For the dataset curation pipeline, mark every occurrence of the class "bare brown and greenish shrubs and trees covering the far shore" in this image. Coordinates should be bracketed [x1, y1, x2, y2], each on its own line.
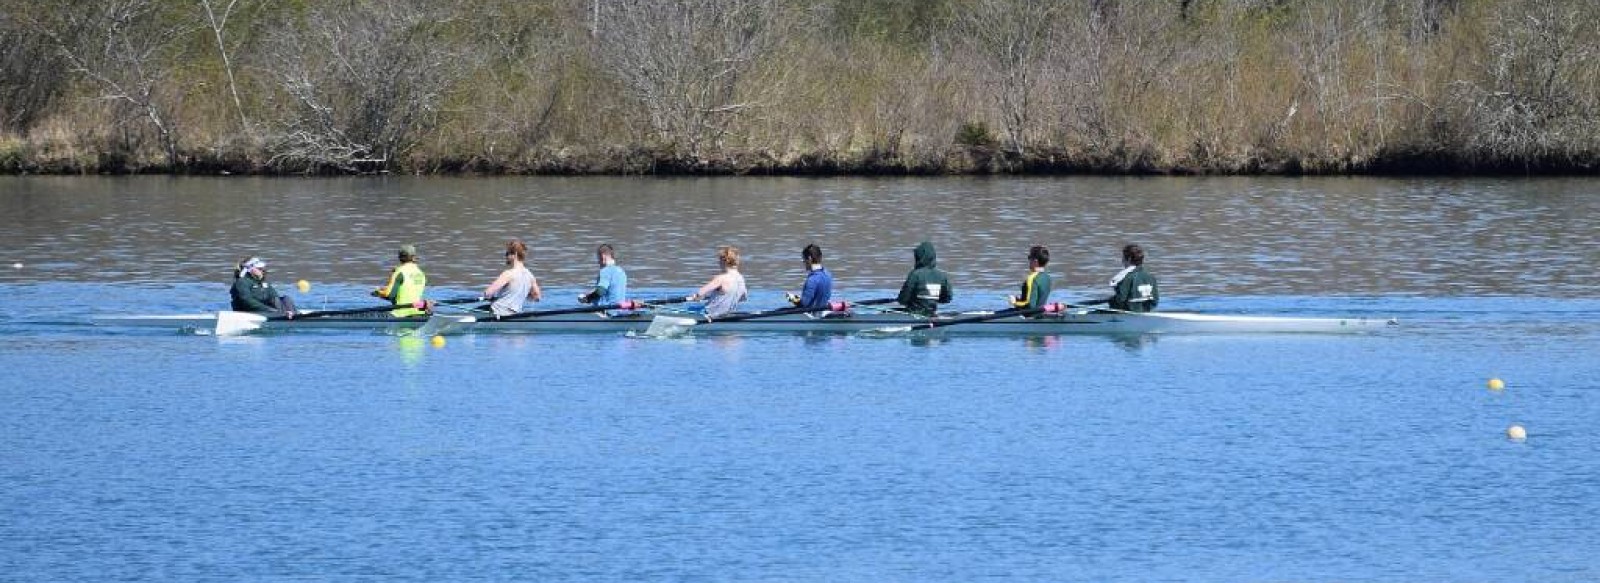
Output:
[0, 0, 1600, 175]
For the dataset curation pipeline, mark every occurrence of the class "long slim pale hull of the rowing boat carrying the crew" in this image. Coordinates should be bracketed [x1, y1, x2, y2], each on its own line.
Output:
[93, 309, 1397, 336]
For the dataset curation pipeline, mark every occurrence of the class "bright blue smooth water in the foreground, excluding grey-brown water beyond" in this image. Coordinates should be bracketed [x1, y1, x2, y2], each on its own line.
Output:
[0, 283, 1600, 581]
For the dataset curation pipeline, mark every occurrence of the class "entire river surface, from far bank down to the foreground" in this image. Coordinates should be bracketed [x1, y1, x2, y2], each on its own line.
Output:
[0, 178, 1600, 581]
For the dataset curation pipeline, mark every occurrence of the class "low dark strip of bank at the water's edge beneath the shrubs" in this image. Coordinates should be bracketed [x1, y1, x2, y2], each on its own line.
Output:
[9, 146, 1600, 176]
